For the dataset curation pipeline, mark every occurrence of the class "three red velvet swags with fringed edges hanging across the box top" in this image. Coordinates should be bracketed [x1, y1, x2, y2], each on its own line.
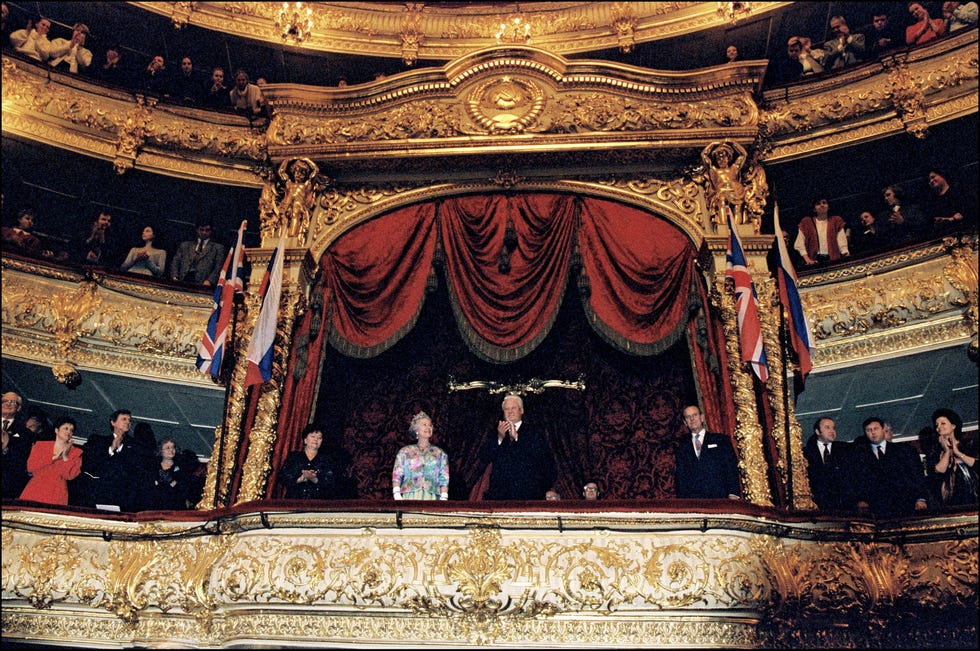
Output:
[322, 194, 697, 363]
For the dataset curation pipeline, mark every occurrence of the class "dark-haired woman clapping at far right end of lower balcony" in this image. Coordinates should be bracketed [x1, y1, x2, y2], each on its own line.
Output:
[926, 408, 977, 506]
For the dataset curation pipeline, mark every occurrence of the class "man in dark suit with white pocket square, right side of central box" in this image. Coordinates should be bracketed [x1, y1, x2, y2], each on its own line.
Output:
[674, 405, 741, 500]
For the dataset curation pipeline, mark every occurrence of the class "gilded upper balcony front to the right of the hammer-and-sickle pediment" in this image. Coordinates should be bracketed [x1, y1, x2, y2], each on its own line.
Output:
[759, 30, 978, 163]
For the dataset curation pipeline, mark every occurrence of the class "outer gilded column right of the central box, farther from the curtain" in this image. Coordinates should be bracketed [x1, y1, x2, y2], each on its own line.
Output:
[755, 277, 816, 509]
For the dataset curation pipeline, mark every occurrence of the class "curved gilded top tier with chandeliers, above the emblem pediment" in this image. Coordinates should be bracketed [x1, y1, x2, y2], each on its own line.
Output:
[130, 2, 790, 60]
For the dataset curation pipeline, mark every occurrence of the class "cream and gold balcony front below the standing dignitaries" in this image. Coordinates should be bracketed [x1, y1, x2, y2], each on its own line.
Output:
[0, 508, 978, 648]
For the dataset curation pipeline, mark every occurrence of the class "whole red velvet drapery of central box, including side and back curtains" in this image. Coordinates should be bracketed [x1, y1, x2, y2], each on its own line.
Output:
[267, 193, 731, 499]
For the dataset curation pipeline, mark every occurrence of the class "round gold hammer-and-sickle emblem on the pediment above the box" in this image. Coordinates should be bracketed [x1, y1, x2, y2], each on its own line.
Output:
[466, 76, 545, 134]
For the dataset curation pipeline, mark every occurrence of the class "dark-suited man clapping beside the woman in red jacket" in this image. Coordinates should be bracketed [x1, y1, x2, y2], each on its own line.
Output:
[70, 409, 145, 511]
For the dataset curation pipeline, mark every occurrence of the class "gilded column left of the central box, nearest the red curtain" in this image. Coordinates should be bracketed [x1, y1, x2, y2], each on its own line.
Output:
[235, 291, 306, 504]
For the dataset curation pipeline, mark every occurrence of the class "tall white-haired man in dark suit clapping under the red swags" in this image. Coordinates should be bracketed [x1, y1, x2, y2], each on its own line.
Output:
[480, 395, 557, 500]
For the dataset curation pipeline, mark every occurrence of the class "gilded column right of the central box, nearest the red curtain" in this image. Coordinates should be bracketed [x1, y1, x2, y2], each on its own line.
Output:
[711, 271, 772, 506]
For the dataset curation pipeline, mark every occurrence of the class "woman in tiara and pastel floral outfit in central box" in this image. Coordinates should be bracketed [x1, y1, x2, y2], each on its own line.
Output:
[391, 411, 449, 500]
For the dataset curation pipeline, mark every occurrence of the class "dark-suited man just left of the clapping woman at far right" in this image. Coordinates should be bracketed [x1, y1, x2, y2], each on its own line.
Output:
[847, 416, 929, 518]
